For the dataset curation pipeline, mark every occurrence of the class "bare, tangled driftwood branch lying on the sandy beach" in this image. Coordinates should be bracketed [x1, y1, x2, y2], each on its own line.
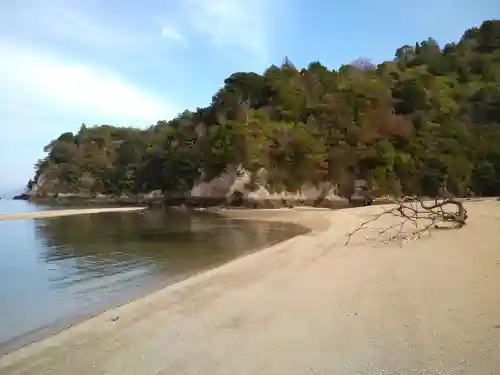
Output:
[345, 197, 467, 245]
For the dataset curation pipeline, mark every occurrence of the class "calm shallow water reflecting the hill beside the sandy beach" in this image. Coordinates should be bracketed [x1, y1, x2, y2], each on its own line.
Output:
[0, 200, 303, 353]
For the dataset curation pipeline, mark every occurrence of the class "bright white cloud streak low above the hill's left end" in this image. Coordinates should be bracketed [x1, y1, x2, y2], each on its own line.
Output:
[0, 42, 175, 124]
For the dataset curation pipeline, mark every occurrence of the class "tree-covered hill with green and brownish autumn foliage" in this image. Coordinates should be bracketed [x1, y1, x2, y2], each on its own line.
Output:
[34, 21, 500, 200]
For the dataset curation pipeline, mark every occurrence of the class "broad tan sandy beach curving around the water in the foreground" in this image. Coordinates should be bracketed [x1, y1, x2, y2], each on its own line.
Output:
[0, 201, 500, 375]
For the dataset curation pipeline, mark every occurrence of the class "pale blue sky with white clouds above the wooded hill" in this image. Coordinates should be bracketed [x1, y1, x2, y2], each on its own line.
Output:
[0, 0, 500, 189]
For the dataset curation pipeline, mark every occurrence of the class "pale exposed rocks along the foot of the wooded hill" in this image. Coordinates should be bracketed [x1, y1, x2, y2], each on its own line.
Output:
[24, 165, 347, 208]
